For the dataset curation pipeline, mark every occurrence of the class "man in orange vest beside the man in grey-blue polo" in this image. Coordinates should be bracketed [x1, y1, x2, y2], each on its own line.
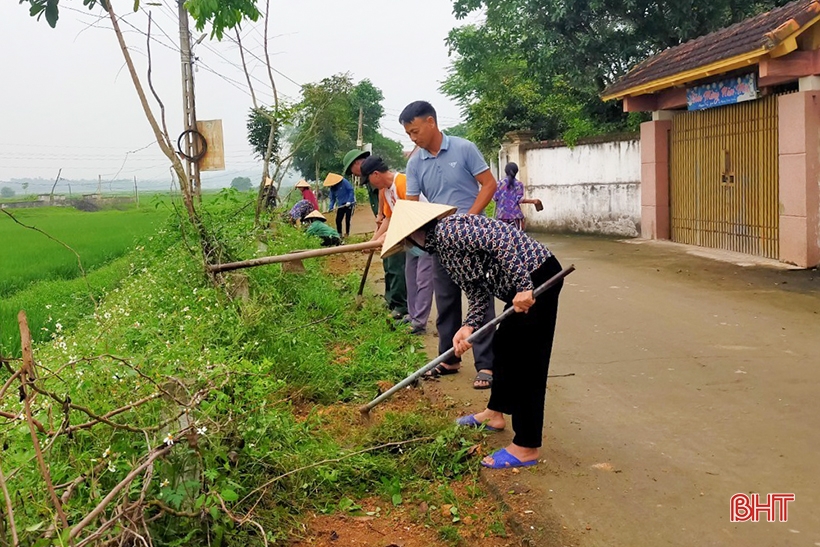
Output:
[361, 156, 433, 335]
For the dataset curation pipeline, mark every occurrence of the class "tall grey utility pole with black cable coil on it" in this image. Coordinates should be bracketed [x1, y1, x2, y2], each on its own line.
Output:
[178, 0, 202, 202]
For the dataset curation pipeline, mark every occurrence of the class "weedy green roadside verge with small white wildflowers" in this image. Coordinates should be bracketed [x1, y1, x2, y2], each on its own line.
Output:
[0, 191, 486, 546]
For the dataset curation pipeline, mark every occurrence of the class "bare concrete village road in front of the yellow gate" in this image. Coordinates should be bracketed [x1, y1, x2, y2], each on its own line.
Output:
[428, 235, 820, 547]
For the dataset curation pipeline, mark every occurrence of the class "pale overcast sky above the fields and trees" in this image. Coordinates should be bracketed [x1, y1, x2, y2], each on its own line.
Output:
[0, 0, 474, 189]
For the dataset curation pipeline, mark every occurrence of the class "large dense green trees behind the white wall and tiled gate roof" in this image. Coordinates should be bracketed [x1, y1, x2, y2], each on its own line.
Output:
[442, 0, 788, 152]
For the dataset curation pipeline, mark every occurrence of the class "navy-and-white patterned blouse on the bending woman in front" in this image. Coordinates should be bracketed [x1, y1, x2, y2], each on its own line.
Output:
[424, 215, 552, 328]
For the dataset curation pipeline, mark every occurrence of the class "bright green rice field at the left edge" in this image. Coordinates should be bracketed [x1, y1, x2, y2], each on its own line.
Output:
[0, 205, 168, 298]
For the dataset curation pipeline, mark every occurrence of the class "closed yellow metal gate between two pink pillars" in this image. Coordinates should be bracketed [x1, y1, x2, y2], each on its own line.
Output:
[669, 96, 779, 259]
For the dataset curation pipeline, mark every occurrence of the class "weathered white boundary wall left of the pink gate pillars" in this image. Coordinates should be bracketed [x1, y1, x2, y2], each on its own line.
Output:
[499, 136, 641, 237]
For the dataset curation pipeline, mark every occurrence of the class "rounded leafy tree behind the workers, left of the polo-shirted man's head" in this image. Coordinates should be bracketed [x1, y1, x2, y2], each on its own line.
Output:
[289, 74, 406, 180]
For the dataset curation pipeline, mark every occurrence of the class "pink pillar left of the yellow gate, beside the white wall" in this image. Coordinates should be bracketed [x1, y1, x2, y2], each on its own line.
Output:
[641, 120, 672, 239]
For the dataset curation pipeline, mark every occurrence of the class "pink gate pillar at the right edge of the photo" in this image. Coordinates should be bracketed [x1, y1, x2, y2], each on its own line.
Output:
[778, 91, 820, 268]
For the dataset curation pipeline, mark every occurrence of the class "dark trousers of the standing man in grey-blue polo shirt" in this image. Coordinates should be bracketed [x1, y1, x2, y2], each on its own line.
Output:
[433, 255, 495, 370]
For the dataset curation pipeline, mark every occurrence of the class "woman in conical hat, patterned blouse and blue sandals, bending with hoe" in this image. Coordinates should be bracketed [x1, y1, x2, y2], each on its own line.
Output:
[381, 200, 562, 469]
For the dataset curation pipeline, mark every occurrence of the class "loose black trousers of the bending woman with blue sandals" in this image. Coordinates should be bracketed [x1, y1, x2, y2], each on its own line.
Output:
[487, 257, 563, 448]
